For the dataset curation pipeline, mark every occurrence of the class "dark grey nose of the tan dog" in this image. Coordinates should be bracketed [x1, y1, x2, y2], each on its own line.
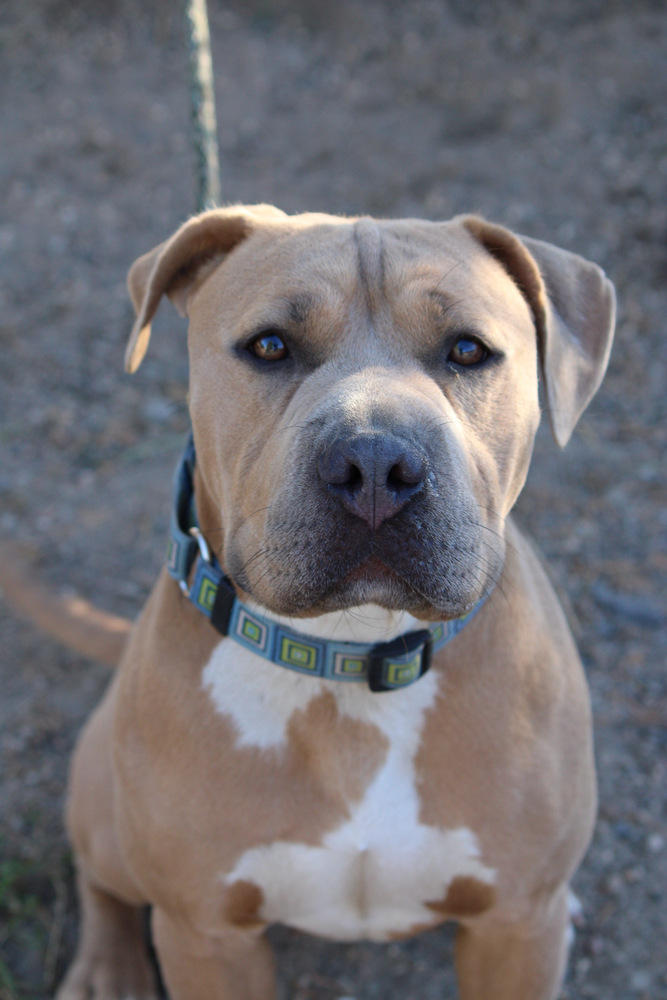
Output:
[317, 433, 428, 529]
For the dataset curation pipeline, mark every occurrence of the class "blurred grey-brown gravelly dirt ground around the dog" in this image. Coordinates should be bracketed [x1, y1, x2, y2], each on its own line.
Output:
[0, 0, 667, 1000]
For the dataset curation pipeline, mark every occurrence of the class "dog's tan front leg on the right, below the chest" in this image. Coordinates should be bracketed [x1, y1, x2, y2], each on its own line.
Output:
[456, 887, 570, 1000]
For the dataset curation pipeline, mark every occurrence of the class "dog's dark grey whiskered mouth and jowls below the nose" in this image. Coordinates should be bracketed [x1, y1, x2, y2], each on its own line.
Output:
[227, 480, 504, 620]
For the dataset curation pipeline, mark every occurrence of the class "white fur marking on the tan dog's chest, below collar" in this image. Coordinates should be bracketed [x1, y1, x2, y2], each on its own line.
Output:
[204, 643, 494, 941]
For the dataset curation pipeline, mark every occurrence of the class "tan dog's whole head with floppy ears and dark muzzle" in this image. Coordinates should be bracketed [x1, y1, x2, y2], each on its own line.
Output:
[126, 206, 614, 619]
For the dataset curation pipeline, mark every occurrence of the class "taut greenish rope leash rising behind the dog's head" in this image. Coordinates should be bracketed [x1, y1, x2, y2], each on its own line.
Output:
[185, 0, 220, 212]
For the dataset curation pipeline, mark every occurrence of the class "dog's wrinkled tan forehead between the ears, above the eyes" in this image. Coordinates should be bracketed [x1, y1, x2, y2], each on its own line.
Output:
[192, 215, 528, 344]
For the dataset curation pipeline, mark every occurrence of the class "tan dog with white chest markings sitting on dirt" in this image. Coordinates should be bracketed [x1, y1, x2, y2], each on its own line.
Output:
[58, 206, 614, 1000]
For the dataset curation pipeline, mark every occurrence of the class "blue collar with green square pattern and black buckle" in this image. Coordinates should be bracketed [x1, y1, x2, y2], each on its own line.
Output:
[167, 434, 486, 691]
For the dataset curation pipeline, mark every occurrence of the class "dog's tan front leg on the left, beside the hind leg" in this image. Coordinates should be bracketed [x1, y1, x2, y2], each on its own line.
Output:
[153, 909, 276, 1000]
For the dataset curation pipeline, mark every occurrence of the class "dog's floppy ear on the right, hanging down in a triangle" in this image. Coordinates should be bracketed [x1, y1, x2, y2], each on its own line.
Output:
[462, 216, 616, 448]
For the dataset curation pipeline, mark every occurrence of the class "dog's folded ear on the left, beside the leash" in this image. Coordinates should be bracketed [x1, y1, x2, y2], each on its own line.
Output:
[125, 205, 285, 372]
